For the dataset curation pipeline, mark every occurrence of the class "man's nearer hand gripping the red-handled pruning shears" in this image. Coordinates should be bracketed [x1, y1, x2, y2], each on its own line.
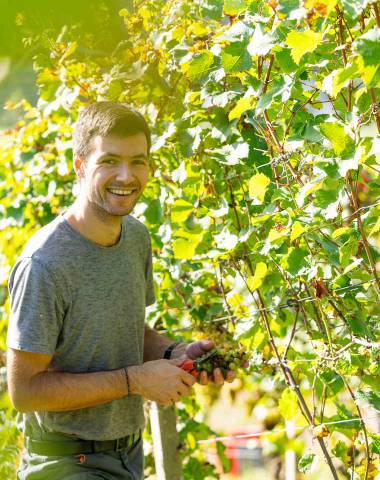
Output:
[128, 359, 195, 405]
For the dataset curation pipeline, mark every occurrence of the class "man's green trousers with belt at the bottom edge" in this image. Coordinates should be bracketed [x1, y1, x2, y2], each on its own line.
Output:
[17, 438, 144, 480]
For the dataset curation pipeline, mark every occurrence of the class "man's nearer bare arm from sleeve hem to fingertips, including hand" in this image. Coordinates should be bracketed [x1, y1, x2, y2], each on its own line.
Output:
[7, 349, 195, 412]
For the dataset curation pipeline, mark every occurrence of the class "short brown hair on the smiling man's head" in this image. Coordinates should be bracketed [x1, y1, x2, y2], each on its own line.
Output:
[73, 101, 151, 160]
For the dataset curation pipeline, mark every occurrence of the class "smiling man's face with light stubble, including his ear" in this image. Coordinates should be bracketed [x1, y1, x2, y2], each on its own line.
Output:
[75, 133, 150, 216]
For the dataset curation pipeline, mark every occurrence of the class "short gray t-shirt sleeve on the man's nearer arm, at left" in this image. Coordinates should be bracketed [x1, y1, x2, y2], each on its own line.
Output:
[7, 258, 64, 354]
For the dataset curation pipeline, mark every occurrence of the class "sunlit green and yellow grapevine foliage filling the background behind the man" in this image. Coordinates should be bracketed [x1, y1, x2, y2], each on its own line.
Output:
[0, 0, 380, 479]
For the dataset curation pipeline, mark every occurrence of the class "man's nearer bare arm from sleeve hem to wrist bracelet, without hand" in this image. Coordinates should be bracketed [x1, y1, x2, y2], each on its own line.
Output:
[7, 348, 128, 412]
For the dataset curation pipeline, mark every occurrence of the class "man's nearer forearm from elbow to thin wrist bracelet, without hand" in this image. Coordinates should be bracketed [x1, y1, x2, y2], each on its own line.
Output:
[14, 369, 128, 412]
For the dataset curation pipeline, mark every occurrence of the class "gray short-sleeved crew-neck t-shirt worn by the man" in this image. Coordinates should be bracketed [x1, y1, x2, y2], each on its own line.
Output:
[7, 215, 155, 440]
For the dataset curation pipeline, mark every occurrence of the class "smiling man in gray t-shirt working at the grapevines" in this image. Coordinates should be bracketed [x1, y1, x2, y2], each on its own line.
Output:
[7, 102, 233, 480]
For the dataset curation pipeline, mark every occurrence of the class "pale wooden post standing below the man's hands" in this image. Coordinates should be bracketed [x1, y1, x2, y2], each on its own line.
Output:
[150, 402, 182, 480]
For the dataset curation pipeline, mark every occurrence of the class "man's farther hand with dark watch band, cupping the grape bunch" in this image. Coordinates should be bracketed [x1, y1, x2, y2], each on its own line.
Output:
[173, 340, 236, 385]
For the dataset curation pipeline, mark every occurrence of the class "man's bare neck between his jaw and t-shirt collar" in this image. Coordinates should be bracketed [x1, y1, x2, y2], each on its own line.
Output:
[63, 197, 122, 247]
